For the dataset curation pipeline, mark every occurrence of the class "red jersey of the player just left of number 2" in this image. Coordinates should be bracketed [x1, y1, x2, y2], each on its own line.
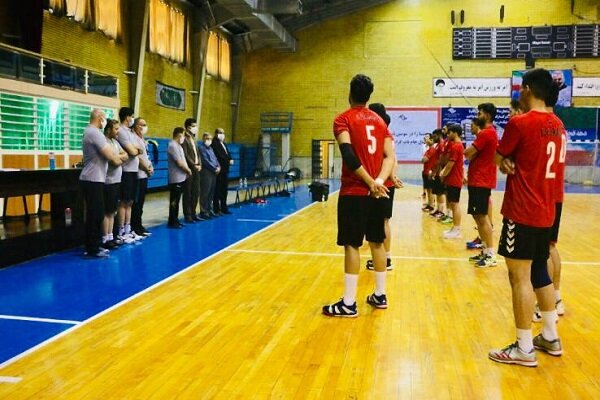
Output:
[468, 126, 498, 189]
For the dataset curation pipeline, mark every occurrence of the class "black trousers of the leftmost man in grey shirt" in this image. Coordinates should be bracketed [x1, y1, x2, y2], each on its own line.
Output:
[80, 181, 104, 254]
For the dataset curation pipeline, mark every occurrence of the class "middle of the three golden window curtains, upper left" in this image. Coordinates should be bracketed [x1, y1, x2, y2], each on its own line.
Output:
[150, 0, 186, 63]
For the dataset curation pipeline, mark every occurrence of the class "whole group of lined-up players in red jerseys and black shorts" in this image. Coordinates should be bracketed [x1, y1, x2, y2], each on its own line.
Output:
[322, 68, 567, 367]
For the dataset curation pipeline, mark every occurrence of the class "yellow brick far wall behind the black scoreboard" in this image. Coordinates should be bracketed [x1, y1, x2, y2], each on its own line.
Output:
[236, 0, 600, 156]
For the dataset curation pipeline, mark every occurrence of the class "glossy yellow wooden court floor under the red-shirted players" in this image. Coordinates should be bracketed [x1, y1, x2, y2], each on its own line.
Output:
[0, 187, 600, 399]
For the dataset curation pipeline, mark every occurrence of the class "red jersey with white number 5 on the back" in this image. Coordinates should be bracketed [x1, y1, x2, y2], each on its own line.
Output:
[333, 106, 392, 196]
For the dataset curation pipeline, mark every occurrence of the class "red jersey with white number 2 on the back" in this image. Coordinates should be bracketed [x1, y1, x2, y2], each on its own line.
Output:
[497, 110, 565, 228]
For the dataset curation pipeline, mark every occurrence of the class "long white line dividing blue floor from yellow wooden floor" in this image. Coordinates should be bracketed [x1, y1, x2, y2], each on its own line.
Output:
[0, 192, 328, 370]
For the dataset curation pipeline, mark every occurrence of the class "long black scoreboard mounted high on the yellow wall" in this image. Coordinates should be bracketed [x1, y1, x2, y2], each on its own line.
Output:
[452, 24, 600, 60]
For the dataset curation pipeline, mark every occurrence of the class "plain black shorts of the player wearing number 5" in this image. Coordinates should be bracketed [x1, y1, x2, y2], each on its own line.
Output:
[337, 196, 387, 247]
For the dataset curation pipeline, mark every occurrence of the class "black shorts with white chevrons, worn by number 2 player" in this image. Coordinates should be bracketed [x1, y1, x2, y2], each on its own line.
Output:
[498, 218, 551, 265]
